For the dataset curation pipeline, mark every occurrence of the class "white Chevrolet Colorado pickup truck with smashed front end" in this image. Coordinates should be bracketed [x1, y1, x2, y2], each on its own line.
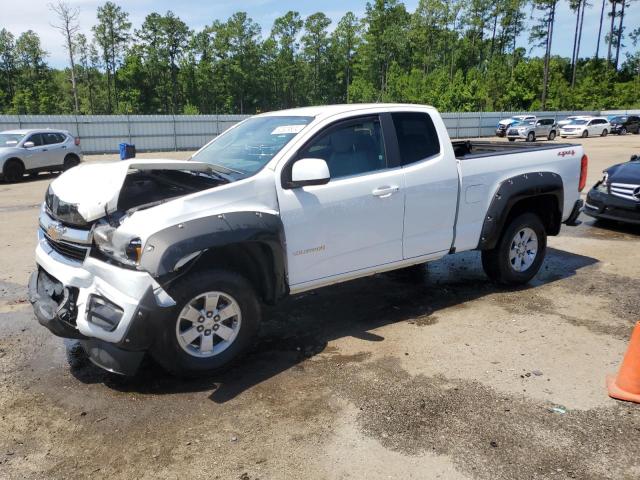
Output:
[29, 104, 587, 375]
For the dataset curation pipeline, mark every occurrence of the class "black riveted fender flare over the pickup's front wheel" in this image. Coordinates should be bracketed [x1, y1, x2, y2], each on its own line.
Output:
[140, 211, 289, 303]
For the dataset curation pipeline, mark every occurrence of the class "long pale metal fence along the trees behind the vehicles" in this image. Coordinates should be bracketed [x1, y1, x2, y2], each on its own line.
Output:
[0, 111, 620, 153]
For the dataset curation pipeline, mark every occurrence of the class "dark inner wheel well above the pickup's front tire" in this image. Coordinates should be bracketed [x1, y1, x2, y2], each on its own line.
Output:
[191, 242, 283, 304]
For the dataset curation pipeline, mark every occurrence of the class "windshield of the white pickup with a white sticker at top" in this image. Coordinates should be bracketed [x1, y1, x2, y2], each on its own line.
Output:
[192, 116, 313, 178]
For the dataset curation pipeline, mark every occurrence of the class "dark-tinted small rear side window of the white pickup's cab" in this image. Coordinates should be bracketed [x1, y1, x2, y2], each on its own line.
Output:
[391, 112, 440, 165]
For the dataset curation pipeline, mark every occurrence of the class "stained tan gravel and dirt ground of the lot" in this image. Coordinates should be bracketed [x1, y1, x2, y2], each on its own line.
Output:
[0, 135, 640, 480]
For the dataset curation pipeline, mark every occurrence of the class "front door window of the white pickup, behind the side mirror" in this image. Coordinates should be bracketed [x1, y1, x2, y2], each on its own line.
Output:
[298, 118, 387, 180]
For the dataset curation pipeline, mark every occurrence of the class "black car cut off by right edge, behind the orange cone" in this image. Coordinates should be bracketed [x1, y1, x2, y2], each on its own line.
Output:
[584, 155, 640, 224]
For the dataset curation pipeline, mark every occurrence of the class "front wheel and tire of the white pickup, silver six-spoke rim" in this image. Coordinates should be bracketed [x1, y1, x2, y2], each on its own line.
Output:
[150, 270, 260, 377]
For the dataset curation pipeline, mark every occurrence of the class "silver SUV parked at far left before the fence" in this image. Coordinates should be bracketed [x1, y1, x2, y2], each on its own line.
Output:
[0, 129, 83, 182]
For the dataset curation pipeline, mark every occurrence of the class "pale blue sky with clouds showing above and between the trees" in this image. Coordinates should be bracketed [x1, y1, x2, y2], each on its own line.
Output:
[0, 0, 640, 68]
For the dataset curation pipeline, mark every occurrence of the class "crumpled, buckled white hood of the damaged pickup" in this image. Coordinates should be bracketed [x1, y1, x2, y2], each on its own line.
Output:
[50, 160, 216, 222]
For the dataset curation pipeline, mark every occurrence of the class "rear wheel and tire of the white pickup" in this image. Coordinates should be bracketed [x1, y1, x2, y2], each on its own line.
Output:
[482, 213, 547, 285]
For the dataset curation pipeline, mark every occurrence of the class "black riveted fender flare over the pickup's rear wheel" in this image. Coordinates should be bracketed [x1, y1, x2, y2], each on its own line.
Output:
[478, 172, 564, 250]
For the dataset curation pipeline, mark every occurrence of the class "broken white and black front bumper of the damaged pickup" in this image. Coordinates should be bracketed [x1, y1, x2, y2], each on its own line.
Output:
[29, 234, 175, 373]
